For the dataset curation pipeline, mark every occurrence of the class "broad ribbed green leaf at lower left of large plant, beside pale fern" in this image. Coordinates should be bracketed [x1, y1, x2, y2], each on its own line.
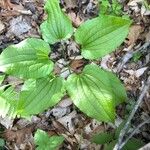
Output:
[17, 77, 65, 117]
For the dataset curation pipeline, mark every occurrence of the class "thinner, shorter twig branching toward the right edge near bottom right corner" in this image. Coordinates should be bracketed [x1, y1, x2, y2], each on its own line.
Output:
[120, 119, 150, 149]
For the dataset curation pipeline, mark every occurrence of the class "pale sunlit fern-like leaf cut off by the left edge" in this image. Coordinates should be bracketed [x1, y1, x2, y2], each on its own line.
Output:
[0, 87, 18, 118]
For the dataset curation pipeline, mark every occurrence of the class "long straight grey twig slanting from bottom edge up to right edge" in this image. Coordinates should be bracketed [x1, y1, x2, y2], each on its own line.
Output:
[113, 76, 150, 150]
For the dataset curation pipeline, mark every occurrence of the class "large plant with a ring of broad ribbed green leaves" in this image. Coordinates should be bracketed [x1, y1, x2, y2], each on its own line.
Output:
[0, 0, 131, 122]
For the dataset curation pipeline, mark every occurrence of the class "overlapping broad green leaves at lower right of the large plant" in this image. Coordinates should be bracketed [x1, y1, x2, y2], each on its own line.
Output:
[66, 65, 126, 122]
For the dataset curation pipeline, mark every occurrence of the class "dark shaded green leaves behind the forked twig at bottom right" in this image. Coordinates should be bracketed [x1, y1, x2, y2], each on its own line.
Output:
[91, 122, 144, 150]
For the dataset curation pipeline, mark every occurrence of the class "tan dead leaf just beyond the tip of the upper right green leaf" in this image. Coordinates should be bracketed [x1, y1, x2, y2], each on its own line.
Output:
[127, 25, 143, 45]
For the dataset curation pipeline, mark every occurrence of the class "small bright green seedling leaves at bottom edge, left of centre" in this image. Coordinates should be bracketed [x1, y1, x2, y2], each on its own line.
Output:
[34, 129, 64, 150]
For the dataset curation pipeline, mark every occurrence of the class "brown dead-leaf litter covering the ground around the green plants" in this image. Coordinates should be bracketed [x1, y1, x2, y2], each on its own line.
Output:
[0, 0, 150, 150]
